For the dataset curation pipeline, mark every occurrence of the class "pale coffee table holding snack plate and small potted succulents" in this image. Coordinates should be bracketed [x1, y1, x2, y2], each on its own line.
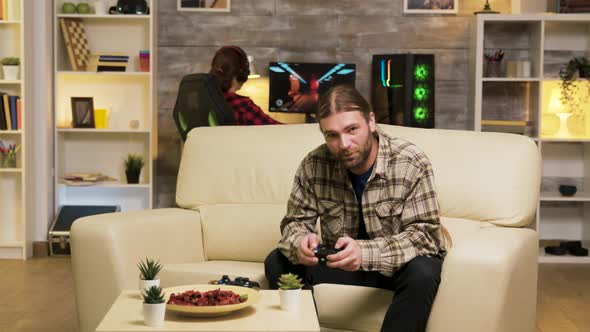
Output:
[96, 290, 320, 332]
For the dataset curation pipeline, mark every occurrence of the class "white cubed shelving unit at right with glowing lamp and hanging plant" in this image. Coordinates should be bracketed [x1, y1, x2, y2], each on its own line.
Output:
[472, 14, 590, 264]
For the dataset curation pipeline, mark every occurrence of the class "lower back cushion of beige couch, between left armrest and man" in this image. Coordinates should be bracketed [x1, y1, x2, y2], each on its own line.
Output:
[198, 204, 287, 262]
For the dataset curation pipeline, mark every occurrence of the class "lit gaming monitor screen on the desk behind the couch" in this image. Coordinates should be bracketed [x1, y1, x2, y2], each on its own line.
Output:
[268, 62, 356, 114]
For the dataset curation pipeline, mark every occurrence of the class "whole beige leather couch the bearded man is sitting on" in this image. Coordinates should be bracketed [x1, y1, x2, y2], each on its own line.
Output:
[72, 124, 540, 332]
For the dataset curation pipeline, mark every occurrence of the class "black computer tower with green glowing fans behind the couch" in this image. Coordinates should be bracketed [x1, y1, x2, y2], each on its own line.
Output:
[371, 54, 435, 128]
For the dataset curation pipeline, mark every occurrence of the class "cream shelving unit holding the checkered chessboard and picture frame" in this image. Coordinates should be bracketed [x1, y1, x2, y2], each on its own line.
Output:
[54, 0, 157, 213]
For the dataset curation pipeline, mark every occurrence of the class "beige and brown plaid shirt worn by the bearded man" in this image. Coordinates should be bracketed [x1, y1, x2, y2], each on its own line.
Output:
[279, 132, 446, 276]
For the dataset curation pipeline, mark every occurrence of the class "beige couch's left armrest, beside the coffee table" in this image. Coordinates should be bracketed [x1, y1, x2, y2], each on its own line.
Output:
[71, 209, 204, 332]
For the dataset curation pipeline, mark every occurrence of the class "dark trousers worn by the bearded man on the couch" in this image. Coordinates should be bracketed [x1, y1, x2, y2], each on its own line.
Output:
[264, 249, 442, 332]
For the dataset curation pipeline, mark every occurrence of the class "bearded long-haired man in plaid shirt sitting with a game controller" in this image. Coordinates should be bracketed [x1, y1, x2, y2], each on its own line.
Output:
[265, 86, 450, 332]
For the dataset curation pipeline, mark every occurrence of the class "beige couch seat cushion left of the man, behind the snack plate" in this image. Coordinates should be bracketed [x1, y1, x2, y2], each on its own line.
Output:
[159, 261, 268, 289]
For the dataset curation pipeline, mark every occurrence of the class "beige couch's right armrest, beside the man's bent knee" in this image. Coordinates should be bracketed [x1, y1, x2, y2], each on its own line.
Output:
[428, 227, 538, 332]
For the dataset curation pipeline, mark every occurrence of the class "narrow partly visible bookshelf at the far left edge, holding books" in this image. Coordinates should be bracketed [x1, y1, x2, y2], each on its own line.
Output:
[0, 0, 34, 259]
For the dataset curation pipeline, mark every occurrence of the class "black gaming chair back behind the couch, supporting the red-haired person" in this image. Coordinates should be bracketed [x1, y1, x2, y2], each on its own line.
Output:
[172, 74, 236, 142]
